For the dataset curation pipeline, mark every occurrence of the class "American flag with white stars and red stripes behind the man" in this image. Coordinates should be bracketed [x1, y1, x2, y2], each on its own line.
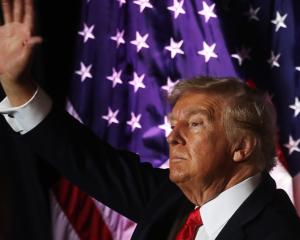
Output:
[52, 0, 300, 239]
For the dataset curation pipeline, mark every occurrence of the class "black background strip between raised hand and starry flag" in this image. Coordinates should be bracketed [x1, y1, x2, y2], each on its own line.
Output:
[33, 0, 82, 105]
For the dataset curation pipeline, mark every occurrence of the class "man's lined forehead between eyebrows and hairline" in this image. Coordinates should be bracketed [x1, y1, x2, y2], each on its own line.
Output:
[170, 91, 224, 118]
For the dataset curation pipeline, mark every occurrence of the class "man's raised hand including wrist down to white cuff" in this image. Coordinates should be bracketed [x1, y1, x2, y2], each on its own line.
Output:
[0, 0, 42, 105]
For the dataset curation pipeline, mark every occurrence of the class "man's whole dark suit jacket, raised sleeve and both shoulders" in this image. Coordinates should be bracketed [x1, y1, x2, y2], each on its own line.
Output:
[14, 110, 300, 240]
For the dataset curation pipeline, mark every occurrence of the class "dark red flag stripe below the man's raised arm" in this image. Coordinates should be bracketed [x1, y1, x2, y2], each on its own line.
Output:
[52, 177, 112, 240]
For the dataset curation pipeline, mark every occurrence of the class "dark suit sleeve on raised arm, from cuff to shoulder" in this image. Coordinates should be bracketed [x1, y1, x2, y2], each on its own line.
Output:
[18, 107, 170, 222]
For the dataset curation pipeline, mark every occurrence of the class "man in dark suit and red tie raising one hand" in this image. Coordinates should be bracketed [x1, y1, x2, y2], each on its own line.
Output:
[0, 0, 300, 240]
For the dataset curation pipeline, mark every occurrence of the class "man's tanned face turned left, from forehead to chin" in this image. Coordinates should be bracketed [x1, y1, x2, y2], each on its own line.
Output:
[168, 91, 233, 189]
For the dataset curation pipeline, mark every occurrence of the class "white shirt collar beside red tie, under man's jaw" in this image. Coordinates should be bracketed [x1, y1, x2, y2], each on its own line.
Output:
[200, 173, 261, 237]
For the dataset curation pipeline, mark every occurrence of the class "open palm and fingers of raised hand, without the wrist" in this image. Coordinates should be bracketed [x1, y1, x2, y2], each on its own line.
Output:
[0, 0, 41, 81]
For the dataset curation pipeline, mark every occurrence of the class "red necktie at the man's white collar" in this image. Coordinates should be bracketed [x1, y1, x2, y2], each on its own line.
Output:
[176, 207, 203, 240]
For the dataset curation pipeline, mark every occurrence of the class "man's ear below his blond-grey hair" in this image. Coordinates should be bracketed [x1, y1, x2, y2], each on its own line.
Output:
[232, 134, 257, 162]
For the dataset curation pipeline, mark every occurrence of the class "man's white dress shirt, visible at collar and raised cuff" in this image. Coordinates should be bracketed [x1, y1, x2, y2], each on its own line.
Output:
[0, 88, 260, 240]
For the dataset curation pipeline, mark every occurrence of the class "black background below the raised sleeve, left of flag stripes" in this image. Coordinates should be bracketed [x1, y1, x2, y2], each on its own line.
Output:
[0, 116, 55, 240]
